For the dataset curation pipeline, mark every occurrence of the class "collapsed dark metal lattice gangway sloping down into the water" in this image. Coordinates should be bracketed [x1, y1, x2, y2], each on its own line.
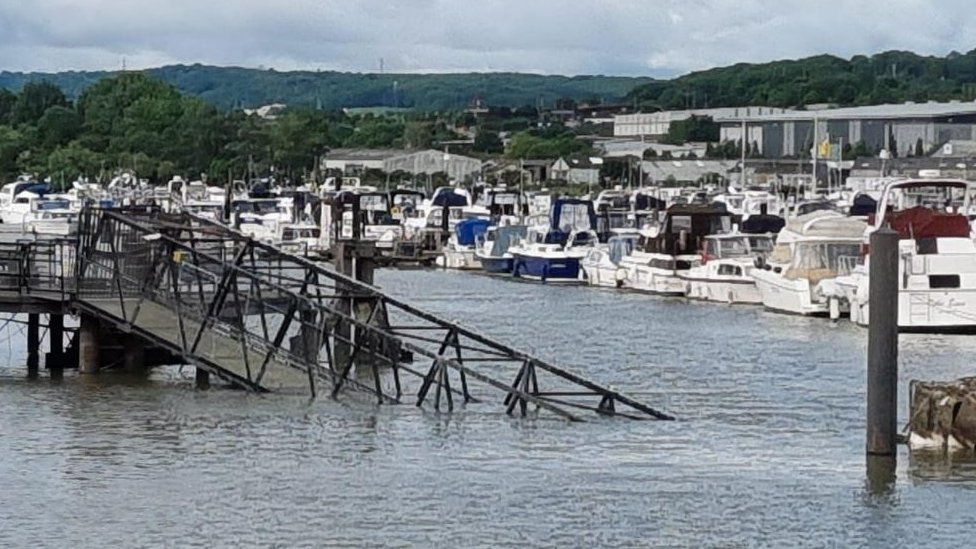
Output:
[76, 208, 672, 421]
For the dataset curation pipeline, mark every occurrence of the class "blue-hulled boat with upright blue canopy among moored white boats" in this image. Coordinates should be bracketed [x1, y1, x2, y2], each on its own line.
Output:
[509, 198, 598, 283]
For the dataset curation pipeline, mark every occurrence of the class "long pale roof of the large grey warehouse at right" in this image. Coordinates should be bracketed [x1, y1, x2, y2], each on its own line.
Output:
[716, 101, 976, 122]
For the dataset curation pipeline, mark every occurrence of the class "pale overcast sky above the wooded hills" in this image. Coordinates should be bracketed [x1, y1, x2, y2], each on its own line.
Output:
[0, 0, 976, 76]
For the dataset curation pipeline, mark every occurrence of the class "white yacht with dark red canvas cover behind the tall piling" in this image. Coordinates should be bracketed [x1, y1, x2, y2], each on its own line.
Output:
[835, 179, 976, 332]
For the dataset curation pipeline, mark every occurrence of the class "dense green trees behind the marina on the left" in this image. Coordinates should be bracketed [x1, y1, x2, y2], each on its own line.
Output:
[0, 73, 491, 184]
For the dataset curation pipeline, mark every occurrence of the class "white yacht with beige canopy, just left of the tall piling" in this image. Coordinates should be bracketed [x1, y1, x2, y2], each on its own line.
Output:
[752, 210, 867, 315]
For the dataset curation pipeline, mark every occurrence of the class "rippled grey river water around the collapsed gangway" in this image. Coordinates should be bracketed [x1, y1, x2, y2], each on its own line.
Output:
[0, 271, 976, 547]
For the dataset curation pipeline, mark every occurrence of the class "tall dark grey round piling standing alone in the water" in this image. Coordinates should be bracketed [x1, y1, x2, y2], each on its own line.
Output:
[867, 227, 898, 456]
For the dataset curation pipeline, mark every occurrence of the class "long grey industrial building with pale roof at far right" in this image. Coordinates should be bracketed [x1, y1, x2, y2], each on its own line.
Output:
[714, 101, 976, 158]
